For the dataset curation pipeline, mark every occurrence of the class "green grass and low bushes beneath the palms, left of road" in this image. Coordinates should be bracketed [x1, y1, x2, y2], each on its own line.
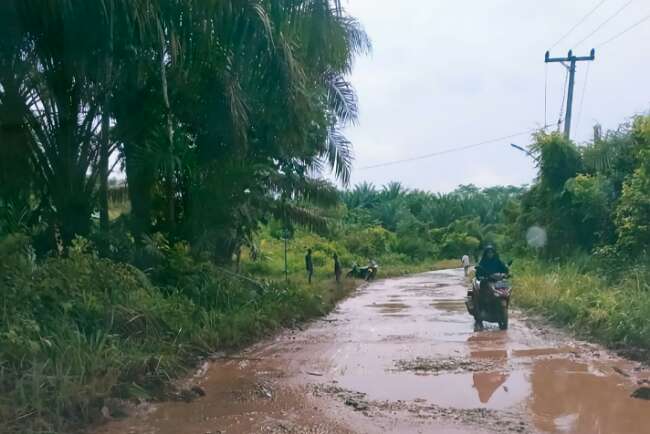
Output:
[0, 235, 342, 432]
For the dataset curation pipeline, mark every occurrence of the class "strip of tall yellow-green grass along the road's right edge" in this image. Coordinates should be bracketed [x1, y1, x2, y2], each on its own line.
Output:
[514, 260, 650, 349]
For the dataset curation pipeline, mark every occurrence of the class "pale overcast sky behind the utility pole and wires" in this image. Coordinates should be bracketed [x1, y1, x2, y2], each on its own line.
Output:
[344, 0, 650, 191]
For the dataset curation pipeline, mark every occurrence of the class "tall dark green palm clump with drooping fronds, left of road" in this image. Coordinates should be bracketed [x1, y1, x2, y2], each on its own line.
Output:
[0, 0, 370, 254]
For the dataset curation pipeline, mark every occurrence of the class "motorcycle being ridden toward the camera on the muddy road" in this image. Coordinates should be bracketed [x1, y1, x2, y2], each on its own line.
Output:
[465, 273, 512, 330]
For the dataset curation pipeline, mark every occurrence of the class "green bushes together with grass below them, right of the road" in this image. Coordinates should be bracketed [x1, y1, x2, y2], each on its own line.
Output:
[509, 116, 650, 352]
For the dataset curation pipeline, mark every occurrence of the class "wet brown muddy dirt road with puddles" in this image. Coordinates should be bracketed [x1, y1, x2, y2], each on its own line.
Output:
[97, 270, 650, 434]
